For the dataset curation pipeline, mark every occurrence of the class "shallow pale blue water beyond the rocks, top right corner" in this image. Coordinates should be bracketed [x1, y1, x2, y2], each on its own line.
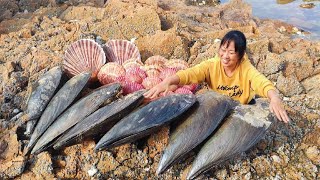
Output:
[221, 0, 320, 40]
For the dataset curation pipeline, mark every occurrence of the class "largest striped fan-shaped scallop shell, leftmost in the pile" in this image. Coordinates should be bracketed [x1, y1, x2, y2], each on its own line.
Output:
[62, 39, 106, 81]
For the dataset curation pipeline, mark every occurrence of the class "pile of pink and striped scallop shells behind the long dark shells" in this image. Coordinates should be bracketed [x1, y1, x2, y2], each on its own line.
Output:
[63, 39, 197, 95]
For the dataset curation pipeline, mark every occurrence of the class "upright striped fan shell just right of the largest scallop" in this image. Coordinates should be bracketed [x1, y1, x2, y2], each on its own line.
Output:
[103, 40, 141, 65]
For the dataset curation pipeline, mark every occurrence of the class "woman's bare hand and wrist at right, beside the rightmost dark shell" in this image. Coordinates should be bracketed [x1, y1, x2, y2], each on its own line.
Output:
[268, 89, 290, 123]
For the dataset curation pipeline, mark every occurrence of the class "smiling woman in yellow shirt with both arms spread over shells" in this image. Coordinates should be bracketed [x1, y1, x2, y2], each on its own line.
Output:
[144, 30, 290, 123]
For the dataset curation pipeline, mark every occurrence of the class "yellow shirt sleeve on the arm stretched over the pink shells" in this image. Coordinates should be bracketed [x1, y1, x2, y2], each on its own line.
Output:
[176, 59, 212, 85]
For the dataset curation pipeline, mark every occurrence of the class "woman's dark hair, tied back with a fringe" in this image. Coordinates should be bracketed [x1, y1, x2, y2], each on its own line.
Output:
[220, 30, 247, 59]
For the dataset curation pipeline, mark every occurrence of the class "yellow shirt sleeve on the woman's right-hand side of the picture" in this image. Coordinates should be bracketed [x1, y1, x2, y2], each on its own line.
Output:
[248, 64, 276, 97]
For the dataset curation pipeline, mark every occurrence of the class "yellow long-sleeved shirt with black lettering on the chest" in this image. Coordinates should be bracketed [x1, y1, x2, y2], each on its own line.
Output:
[176, 55, 275, 104]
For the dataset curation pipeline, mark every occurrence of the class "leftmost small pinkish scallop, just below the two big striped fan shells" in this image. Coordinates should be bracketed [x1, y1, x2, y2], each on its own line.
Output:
[98, 62, 126, 85]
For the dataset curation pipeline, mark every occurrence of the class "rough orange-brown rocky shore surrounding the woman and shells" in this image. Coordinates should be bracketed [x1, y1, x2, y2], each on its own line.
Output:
[0, 0, 320, 179]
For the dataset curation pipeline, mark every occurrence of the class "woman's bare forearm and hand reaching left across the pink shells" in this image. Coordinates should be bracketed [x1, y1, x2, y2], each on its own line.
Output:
[144, 74, 180, 99]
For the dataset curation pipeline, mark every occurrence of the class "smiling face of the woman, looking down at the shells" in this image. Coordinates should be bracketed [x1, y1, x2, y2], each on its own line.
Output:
[219, 41, 240, 69]
